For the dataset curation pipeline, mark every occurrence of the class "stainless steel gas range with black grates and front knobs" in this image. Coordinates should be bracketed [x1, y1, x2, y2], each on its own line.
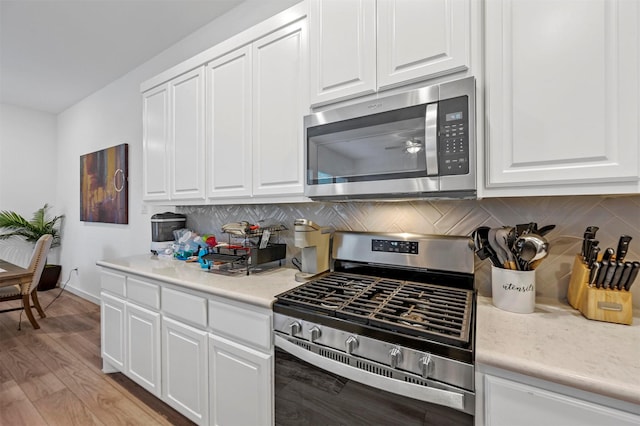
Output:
[273, 232, 475, 425]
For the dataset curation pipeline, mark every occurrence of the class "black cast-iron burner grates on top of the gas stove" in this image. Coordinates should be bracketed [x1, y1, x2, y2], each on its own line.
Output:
[277, 272, 473, 344]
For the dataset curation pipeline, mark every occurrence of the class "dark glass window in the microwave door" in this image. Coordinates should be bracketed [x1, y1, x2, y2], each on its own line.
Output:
[307, 104, 427, 185]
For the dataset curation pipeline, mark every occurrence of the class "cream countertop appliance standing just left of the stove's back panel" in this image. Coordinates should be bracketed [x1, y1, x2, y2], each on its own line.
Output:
[293, 219, 331, 281]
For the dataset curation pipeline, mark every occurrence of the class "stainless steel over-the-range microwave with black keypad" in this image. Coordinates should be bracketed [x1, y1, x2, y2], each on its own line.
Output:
[304, 77, 477, 200]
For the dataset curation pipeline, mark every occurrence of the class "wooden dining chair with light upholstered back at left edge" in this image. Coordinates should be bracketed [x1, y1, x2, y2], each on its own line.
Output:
[0, 234, 53, 328]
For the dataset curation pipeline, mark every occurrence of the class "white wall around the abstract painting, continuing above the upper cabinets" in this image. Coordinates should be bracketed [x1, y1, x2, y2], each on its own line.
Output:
[56, 0, 298, 301]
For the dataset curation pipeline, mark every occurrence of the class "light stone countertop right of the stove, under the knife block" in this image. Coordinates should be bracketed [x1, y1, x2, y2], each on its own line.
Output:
[476, 296, 640, 404]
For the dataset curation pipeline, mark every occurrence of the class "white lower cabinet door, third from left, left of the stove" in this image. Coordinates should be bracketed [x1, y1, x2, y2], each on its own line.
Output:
[162, 318, 209, 424]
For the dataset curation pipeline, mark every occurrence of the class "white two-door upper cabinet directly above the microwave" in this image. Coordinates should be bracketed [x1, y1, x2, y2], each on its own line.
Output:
[309, 0, 471, 105]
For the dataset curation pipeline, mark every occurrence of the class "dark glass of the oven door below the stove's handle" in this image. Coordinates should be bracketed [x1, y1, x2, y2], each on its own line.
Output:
[275, 348, 473, 426]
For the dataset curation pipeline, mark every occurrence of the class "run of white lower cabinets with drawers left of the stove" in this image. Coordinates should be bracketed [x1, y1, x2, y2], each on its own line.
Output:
[101, 269, 274, 426]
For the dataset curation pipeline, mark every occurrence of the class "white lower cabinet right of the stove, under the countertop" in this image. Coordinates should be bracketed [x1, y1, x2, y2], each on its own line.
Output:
[476, 369, 640, 426]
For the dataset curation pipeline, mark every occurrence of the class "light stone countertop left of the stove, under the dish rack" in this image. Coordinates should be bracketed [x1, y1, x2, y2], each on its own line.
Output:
[96, 254, 301, 309]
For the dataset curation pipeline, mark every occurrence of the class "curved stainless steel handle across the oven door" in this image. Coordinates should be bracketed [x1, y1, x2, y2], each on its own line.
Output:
[274, 334, 464, 411]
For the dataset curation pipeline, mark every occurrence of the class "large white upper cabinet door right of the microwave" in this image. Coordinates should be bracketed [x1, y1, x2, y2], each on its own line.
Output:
[485, 0, 640, 190]
